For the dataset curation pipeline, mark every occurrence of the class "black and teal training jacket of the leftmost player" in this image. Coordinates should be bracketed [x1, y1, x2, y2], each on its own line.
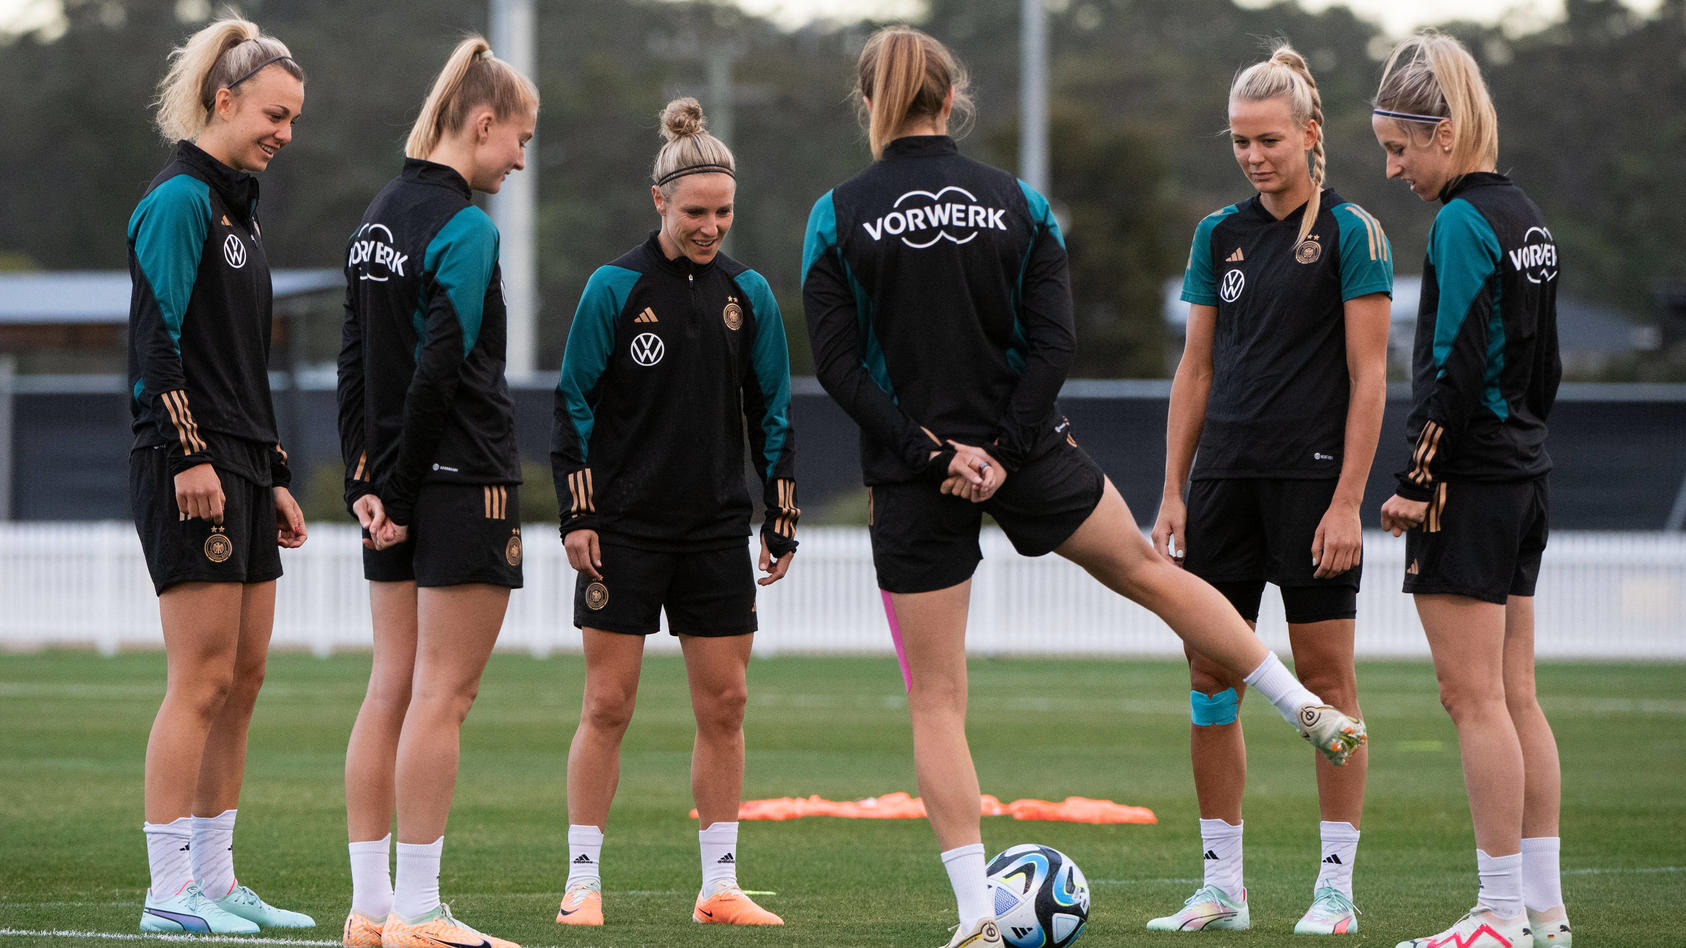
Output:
[128, 140, 292, 487]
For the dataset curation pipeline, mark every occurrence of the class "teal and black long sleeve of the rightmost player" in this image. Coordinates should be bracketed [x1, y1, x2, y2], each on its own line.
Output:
[1398, 201, 1504, 501]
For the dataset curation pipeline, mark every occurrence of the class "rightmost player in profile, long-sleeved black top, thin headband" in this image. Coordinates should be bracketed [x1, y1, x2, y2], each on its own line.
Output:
[1371, 30, 1571, 948]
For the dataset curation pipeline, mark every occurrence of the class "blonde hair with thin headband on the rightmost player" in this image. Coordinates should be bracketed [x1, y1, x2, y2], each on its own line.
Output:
[1374, 30, 1499, 180]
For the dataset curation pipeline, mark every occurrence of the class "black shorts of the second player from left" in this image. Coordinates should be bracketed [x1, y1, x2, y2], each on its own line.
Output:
[362, 484, 521, 589]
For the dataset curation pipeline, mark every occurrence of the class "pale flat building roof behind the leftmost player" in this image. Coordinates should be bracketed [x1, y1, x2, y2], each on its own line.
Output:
[0, 270, 346, 326]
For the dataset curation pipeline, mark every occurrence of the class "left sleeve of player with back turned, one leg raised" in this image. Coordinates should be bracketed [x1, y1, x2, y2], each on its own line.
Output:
[803, 191, 954, 481]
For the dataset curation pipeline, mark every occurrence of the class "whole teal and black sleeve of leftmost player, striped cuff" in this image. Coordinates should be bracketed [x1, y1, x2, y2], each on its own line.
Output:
[128, 174, 212, 474]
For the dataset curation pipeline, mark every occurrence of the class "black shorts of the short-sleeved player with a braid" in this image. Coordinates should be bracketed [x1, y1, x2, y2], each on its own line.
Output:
[1182, 477, 1364, 622]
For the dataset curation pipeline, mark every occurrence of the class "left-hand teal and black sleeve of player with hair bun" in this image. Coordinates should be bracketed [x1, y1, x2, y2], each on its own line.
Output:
[550, 267, 642, 533]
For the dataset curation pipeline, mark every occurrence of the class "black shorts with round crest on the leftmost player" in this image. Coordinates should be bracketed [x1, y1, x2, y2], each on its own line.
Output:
[128, 445, 282, 594]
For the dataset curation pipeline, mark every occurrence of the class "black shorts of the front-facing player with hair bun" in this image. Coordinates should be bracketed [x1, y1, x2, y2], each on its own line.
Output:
[573, 533, 755, 638]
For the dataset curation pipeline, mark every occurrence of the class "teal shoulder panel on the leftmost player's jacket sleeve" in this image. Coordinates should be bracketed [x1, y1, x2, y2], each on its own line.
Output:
[128, 174, 211, 350]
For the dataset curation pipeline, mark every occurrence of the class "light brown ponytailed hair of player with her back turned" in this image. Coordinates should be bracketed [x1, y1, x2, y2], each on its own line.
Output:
[855, 25, 973, 159]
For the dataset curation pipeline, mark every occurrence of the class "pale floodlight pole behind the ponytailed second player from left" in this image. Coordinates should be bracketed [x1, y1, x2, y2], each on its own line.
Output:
[491, 0, 538, 378]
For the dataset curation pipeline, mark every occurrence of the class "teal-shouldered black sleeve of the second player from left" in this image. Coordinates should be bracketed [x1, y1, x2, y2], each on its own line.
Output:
[381, 206, 497, 526]
